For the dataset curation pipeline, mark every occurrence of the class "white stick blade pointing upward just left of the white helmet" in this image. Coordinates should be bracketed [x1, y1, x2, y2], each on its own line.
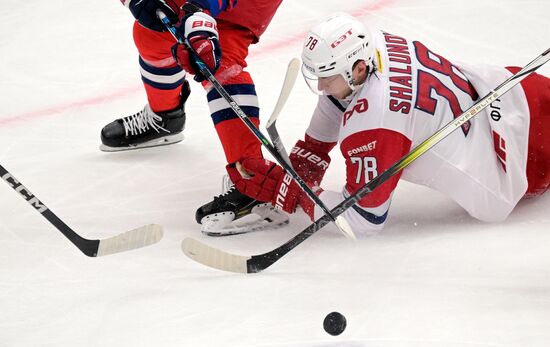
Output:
[265, 58, 300, 166]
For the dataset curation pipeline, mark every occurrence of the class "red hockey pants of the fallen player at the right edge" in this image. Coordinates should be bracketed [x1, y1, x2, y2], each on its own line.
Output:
[508, 67, 550, 197]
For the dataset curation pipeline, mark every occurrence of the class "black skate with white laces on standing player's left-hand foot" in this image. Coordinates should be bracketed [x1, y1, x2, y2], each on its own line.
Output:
[99, 81, 191, 152]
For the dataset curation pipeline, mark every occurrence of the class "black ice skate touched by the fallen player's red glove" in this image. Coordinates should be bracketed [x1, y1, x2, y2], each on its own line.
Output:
[195, 187, 294, 236]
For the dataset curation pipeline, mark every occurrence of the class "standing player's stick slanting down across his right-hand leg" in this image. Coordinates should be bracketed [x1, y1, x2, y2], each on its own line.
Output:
[157, 14, 356, 239]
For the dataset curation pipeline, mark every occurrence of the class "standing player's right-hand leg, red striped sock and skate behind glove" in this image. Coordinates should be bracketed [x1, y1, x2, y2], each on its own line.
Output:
[196, 20, 287, 234]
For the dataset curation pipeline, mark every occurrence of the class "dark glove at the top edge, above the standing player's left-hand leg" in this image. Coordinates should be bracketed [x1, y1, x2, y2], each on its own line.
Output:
[122, 0, 181, 31]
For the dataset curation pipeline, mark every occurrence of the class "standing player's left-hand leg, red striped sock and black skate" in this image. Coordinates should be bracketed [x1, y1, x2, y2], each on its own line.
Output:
[100, 22, 190, 151]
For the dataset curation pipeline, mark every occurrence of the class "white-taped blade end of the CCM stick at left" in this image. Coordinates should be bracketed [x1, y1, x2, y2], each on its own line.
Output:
[97, 224, 163, 257]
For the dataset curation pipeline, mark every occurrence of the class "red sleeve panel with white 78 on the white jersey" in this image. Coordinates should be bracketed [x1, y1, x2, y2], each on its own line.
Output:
[340, 129, 411, 207]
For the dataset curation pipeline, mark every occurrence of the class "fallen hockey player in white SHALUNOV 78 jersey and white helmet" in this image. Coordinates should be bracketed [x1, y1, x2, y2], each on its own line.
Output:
[225, 14, 550, 234]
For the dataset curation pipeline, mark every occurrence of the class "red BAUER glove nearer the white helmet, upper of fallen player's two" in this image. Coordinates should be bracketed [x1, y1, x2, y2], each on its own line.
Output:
[289, 134, 336, 186]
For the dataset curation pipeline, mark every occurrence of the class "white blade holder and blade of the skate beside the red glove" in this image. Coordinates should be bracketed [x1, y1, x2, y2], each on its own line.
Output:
[201, 204, 288, 237]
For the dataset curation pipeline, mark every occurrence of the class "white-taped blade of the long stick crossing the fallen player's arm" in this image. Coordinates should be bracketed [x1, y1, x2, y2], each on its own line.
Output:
[181, 238, 251, 273]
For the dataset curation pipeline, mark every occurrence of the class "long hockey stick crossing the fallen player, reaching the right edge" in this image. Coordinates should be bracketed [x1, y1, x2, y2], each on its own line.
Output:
[182, 49, 550, 273]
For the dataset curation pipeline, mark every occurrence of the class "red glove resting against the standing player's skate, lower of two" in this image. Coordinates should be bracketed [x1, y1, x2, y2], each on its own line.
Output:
[227, 157, 320, 216]
